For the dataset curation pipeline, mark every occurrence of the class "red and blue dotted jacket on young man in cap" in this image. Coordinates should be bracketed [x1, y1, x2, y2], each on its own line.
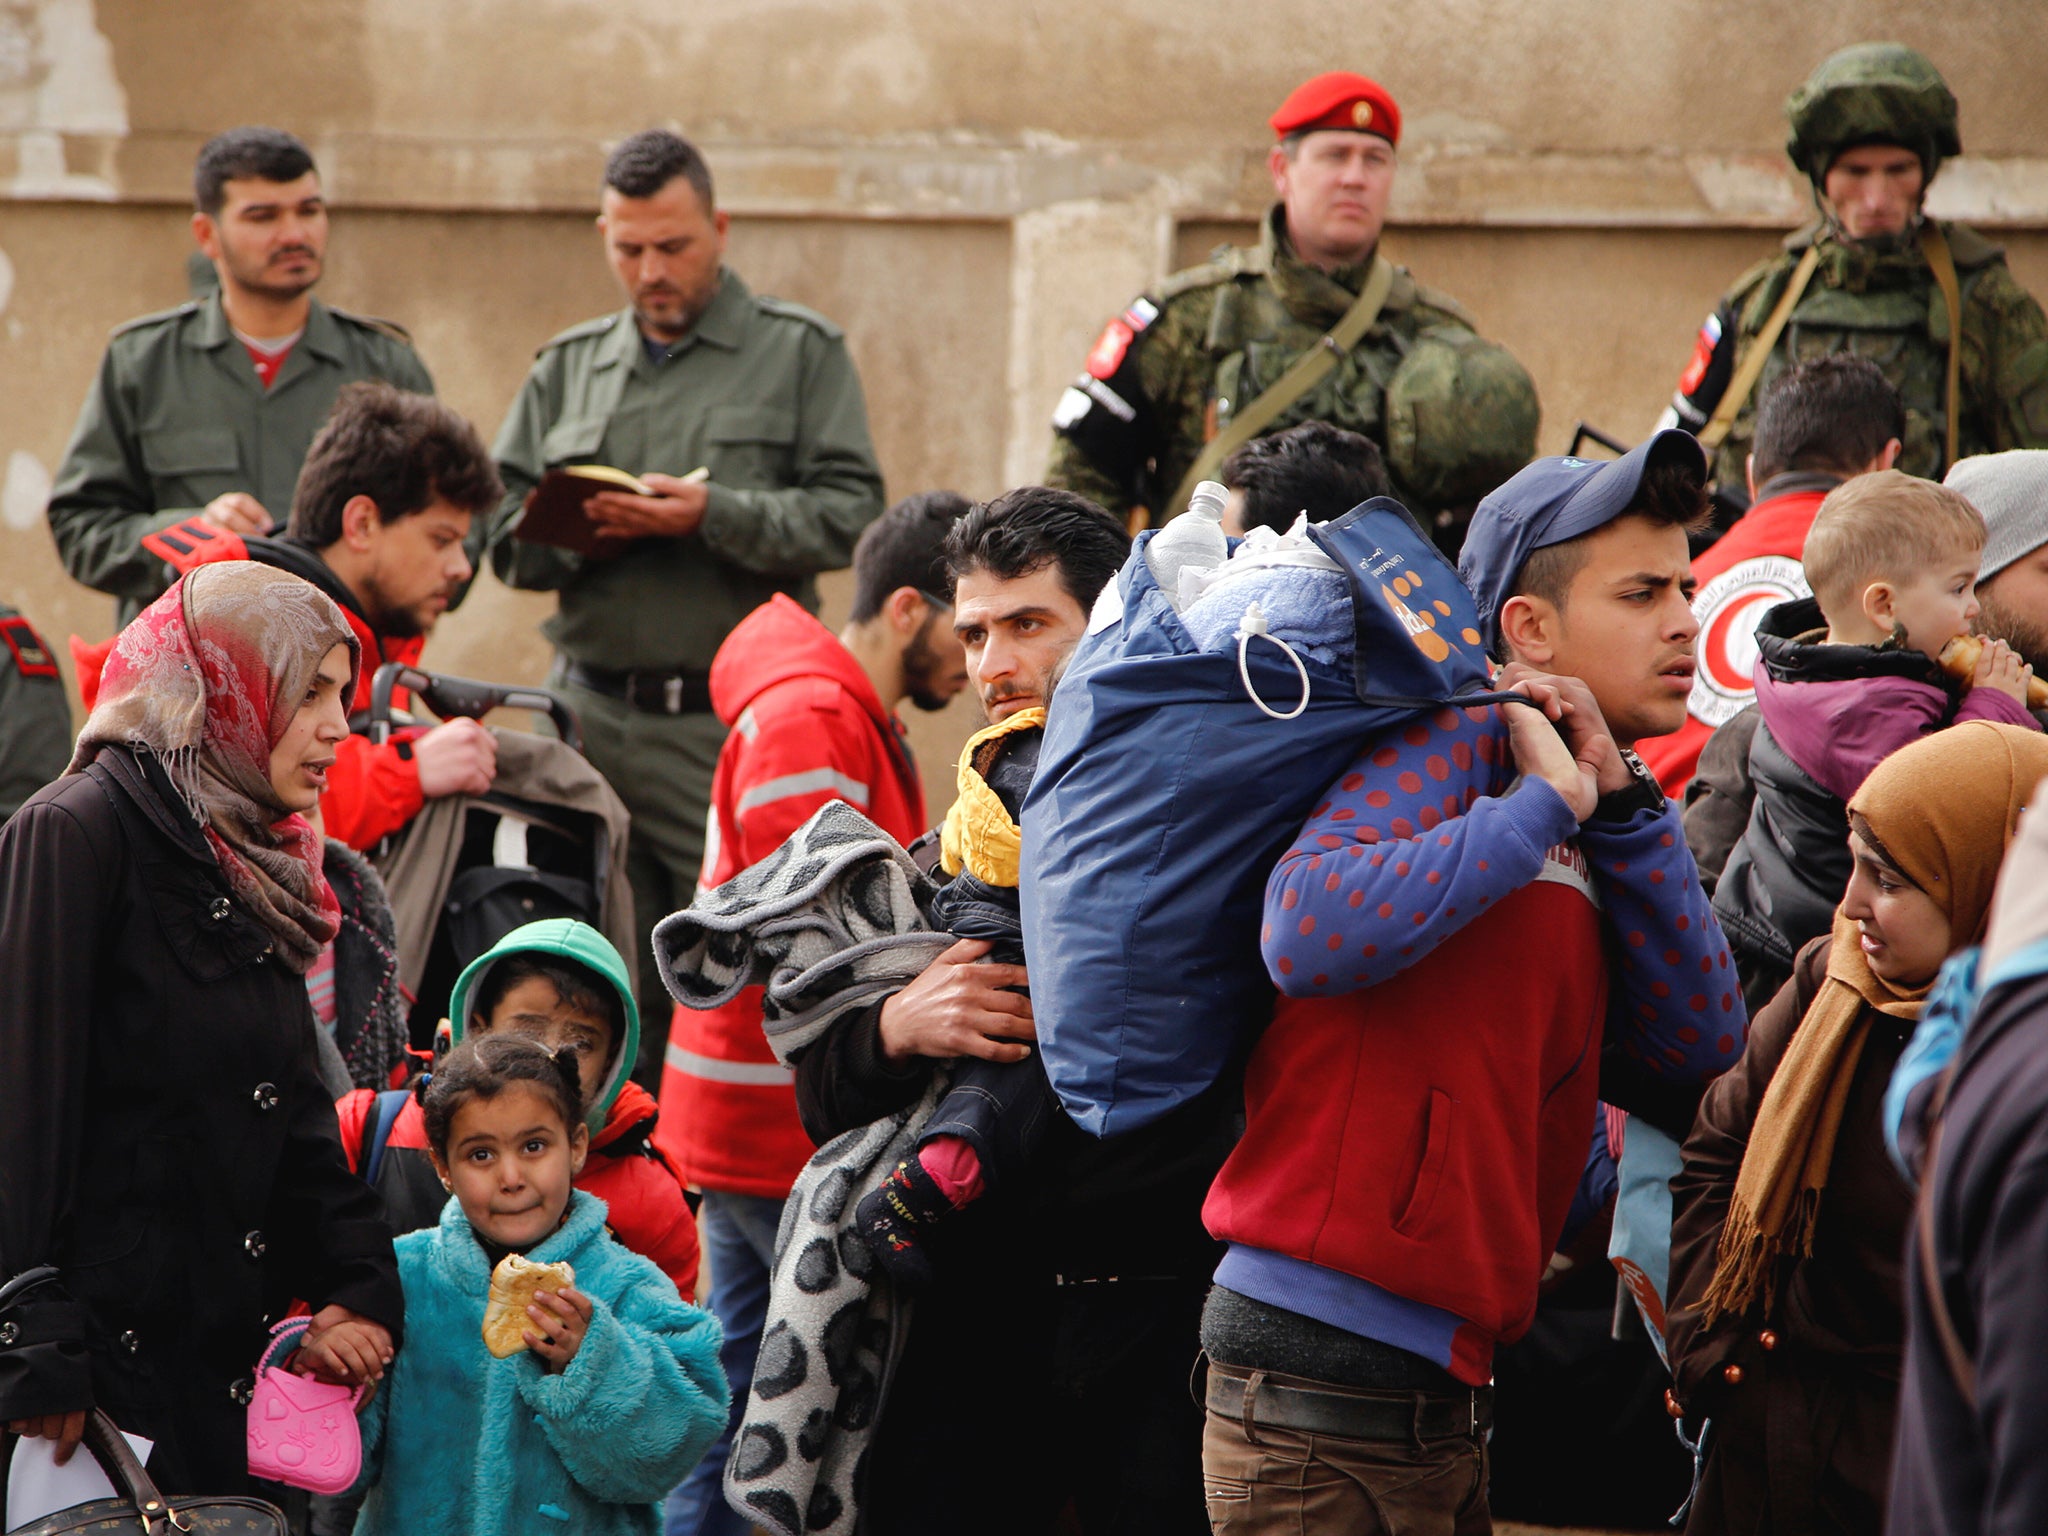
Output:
[1202, 707, 1747, 1384]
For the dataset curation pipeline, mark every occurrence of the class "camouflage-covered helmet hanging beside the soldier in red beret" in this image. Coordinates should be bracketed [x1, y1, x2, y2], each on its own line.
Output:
[1386, 326, 1538, 506]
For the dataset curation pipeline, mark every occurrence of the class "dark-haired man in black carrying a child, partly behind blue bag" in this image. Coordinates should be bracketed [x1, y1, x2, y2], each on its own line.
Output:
[797, 487, 1239, 1536]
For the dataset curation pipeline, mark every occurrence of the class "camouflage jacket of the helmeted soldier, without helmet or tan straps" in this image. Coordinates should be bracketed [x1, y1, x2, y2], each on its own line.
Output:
[1667, 223, 2048, 485]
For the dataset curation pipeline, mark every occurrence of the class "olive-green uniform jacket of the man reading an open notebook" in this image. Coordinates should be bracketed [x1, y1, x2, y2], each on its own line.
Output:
[492, 270, 883, 672]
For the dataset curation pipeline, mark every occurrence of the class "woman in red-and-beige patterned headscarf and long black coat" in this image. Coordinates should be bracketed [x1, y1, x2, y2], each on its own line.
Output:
[0, 561, 403, 1493]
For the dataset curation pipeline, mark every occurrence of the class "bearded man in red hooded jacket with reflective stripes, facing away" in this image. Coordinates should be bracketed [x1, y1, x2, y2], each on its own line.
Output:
[655, 492, 969, 1536]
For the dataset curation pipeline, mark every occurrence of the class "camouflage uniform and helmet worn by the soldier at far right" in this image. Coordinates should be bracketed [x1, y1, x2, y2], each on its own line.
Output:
[1667, 43, 2048, 487]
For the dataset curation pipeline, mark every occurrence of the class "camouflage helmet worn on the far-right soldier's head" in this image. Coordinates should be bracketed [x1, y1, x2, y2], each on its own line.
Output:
[1786, 43, 1962, 186]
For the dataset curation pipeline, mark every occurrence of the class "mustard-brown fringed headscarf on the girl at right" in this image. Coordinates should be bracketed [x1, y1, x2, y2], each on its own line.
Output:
[1702, 721, 2048, 1323]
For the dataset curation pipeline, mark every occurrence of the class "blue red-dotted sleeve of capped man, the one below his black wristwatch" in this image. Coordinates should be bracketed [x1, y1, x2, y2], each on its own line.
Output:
[1579, 801, 1749, 1083]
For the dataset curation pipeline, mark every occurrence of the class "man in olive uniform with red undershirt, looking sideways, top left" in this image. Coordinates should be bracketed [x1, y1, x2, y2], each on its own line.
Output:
[49, 127, 434, 625]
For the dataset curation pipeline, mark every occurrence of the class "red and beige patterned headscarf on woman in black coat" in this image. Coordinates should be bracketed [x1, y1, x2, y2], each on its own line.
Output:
[68, 561, 362, 973]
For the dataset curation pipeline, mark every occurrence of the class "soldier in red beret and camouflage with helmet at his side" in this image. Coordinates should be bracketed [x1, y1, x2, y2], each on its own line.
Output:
[1047, 74, 1538, 553]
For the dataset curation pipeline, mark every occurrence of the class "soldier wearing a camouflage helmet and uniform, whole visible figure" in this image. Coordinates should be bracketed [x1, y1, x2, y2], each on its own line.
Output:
[1661, 43, 2048, 492]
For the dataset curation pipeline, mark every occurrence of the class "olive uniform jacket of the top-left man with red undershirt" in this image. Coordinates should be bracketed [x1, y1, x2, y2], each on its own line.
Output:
[49, 293, 434, 623]
